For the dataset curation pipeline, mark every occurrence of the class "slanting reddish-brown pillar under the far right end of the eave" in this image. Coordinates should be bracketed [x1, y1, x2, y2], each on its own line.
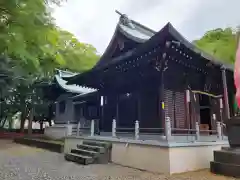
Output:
[221, 68, 230, 119]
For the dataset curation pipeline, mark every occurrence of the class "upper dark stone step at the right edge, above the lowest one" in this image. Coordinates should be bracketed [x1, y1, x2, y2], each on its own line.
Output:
[214, 150, 240, 165]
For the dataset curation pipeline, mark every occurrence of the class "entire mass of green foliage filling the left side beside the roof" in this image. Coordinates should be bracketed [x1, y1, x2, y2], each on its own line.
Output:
[0, 0, 99, 129]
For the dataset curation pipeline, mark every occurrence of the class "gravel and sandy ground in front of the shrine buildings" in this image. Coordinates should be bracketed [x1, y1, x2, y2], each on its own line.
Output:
[0, 141, 237, 180]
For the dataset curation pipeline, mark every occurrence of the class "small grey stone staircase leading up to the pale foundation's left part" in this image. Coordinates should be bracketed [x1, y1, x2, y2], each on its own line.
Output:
[65, 140, 112, 165]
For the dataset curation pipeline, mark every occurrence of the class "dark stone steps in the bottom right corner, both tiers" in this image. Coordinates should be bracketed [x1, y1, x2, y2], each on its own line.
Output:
[210, 147, 240, 178]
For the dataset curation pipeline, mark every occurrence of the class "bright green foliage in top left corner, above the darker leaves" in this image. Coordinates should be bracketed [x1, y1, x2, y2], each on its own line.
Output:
[0, 0, 61, 68]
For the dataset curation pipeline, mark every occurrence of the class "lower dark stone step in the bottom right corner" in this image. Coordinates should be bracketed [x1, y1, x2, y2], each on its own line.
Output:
[210, 161, 240, 178]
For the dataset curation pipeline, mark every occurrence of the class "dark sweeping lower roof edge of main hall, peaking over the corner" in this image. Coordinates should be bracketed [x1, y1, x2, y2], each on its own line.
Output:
[66, 23, 233, 86]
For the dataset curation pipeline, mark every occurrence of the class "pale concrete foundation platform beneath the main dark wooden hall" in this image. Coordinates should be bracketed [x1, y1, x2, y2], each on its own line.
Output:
[64, 136, 228, 174]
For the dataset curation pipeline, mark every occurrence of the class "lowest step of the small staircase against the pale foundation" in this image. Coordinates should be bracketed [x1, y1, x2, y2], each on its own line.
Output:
[65, 153, 94, 165]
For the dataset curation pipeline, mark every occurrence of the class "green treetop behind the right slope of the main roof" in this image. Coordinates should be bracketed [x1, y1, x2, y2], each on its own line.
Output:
[194, 28, 237, 64]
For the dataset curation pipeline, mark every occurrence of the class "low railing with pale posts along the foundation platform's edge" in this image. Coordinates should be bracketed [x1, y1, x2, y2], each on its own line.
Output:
[72, 117, 224, 141]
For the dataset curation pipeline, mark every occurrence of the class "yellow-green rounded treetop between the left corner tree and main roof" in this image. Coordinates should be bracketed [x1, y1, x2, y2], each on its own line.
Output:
[41, 28, 99, 72]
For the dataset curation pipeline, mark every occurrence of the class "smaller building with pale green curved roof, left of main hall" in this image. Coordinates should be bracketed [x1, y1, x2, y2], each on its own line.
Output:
[43, 69, 97, 125]
